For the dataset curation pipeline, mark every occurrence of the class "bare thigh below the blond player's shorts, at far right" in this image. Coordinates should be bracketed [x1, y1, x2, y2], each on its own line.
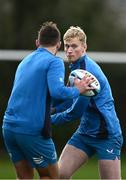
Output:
[99, 158, 121, 179]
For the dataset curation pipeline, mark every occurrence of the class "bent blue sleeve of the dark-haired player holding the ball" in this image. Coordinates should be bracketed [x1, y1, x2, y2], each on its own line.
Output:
[47, 58, 80, 99]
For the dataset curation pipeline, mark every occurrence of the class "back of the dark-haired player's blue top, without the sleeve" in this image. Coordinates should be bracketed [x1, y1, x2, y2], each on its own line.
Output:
[4, 48, 59, 134]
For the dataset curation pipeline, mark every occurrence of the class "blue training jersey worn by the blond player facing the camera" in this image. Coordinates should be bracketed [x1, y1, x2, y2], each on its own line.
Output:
[52, 55, 121, 138]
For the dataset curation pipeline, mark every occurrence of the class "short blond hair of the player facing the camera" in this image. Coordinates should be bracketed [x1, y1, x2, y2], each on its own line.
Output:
[63, 26, 87, 44]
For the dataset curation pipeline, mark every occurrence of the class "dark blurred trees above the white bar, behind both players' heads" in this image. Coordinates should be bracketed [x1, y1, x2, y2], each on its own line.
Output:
[0, 0, 126, 51]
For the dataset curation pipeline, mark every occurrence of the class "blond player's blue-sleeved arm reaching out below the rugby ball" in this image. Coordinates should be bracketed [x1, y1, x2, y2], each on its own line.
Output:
[51, 96, 90, 125]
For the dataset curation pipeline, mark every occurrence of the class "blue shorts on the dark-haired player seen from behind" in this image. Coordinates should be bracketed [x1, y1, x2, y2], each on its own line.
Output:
[3, 130, 57, 168]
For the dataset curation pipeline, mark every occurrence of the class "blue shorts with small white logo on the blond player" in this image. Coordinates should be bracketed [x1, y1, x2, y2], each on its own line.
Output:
[68, 132, 123, 160]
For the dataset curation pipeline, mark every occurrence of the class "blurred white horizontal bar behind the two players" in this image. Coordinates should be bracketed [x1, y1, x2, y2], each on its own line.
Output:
[0, 50, 126, 63]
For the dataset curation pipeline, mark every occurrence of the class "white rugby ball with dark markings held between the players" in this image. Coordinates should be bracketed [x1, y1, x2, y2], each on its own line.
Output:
[68, 69, 100, 96]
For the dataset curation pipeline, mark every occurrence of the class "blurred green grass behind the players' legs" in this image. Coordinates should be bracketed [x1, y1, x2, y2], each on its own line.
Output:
[0, 154, 126, 179]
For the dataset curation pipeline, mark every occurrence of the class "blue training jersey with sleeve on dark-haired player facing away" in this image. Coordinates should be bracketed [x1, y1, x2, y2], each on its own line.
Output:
[3, 48, 79, 135]
